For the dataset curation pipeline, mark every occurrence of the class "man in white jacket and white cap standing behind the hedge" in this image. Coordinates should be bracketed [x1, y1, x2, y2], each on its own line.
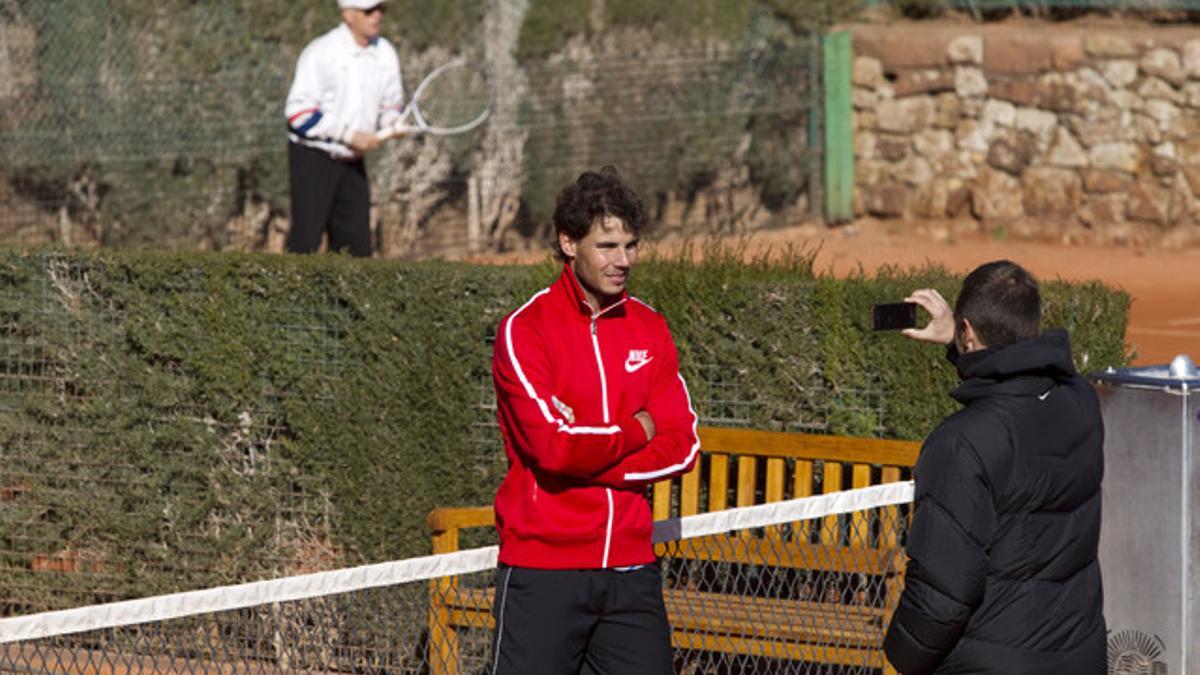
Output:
[286, 0, 404, 256]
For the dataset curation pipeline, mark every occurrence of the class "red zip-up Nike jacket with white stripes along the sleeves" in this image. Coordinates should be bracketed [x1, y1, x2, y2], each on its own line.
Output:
[492, 267, 700, 569]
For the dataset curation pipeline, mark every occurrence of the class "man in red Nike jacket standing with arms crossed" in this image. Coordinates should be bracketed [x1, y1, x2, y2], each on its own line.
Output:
[490, 167, 700, 675]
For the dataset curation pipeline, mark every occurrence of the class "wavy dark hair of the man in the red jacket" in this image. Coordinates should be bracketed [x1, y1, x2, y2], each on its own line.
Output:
[554, 166, 646, 261]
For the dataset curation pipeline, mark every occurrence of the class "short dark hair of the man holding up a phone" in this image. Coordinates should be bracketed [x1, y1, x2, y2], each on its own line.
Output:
[954, 261, 1042, 347]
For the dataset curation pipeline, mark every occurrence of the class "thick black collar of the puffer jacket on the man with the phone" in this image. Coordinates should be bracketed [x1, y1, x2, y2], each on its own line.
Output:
[950, 330, 1076, 404]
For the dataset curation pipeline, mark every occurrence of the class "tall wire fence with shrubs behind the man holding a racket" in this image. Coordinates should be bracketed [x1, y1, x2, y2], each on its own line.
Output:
[0, 0, 821, 257]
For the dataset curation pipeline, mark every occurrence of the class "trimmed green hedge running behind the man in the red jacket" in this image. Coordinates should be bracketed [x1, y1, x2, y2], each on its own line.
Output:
[0, 249, 1129, 613]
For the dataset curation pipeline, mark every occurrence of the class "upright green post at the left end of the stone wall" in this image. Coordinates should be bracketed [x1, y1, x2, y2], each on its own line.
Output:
[821, 30, 854, 223]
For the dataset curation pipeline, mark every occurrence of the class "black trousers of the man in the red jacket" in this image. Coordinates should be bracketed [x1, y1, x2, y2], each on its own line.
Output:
[488, 565, 674, 675]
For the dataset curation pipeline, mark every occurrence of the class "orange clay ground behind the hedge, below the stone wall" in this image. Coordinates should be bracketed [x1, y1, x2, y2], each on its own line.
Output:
[463, 220, 1200, 365]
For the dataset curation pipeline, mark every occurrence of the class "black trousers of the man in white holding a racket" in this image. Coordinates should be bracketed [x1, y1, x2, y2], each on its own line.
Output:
[286, 143, 371, 256]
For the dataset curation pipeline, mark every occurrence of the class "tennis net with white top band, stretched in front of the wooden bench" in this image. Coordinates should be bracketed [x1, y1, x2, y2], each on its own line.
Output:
[0, 482, 912, 675]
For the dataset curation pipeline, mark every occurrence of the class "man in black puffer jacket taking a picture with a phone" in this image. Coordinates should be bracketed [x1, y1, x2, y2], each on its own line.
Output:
[883, 261, 1105, 675]
